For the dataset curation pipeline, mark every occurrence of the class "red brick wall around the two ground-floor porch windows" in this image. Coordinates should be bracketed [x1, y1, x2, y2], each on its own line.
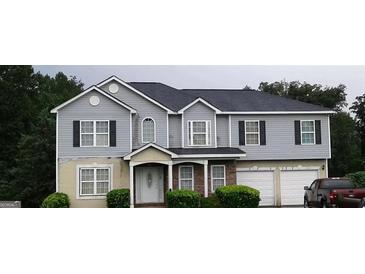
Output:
[172, 160, 236, 196]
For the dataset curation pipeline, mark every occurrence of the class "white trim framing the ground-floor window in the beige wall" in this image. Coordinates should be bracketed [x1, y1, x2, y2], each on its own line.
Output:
[76, 164, 113, 200]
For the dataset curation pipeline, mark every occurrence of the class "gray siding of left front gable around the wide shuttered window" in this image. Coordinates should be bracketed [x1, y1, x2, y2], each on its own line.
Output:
[58, 91, 130, 158]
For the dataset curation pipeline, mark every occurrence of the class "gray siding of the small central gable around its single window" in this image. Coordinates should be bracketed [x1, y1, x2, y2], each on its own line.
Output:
[184, 102, 215, 147]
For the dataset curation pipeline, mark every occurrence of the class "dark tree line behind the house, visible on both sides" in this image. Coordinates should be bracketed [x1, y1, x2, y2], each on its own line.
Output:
[0, 66, 365, 207]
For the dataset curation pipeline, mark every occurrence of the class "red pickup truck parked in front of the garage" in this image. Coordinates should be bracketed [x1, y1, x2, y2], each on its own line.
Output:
[304, 178, 365, 207]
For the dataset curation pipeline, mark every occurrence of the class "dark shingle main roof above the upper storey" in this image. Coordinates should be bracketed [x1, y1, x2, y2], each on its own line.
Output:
[129, 82, 330, 112]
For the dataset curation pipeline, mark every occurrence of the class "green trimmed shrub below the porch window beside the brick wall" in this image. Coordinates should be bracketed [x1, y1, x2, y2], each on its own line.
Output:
[166, 189, 200, 208]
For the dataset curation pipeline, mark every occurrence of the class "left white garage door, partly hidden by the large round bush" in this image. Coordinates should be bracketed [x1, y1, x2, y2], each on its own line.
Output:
[237, 171, 275, 206]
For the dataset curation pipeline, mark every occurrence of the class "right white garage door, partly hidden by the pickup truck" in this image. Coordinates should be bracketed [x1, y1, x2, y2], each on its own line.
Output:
[280, 170, 318, 205]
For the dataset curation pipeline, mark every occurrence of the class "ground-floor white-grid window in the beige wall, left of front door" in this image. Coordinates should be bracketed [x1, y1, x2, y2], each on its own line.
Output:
[79, 168, 110, 196]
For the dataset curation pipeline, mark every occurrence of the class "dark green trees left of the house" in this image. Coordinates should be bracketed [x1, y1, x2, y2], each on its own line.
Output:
[0, 66, 83, 207]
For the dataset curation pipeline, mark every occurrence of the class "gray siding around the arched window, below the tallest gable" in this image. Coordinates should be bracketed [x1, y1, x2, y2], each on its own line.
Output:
[101, 81, 167, 149]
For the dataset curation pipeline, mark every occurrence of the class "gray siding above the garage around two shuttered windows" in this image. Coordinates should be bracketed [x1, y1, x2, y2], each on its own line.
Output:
[231, 114, 331, 160]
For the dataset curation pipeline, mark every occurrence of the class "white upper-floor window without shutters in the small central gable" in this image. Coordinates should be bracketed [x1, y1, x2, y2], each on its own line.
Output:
[188, 121, 211, 146]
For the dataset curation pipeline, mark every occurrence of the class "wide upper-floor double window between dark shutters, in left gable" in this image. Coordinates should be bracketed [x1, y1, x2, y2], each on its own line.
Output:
[80, 121, 109, 147]
